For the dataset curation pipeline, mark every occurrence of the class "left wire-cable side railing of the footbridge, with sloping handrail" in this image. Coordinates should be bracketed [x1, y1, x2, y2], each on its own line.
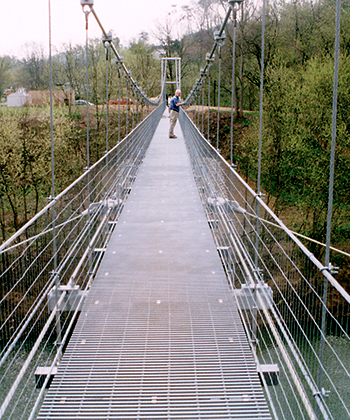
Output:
[0, 104, 165, 420]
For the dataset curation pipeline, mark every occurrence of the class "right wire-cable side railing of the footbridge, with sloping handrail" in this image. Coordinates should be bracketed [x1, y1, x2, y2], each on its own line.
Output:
[180, 112, 350, 420]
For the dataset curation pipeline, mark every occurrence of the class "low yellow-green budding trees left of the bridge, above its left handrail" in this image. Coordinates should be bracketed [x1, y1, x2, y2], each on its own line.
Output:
[0, 107, 148, 240]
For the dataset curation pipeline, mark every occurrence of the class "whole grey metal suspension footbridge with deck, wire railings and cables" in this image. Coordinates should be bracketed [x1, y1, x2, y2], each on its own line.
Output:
[0, 0, 350, 420]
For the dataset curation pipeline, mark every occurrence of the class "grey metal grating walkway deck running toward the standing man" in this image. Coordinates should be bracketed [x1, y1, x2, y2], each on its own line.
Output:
[38, 114, 271, 420]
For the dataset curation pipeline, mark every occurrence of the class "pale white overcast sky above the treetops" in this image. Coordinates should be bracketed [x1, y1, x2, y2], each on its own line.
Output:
[0, 0, 192, 57]
